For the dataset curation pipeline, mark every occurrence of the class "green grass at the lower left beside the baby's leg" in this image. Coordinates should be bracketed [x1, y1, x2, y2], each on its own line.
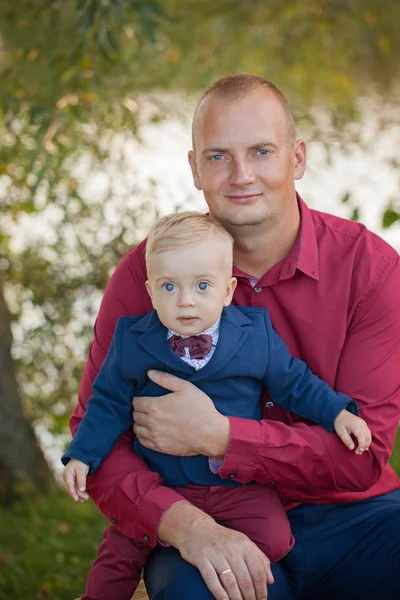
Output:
[0, 435, 400, 600]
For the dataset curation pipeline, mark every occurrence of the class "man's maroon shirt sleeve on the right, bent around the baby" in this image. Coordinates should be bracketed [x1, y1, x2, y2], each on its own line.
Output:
[219, 257, 400, 503]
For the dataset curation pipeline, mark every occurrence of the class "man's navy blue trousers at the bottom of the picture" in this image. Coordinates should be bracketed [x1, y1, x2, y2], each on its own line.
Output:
[145, 489, 400, 600]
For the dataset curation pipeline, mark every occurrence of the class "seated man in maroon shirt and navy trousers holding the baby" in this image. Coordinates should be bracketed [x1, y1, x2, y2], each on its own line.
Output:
[71, 75, 400, 600]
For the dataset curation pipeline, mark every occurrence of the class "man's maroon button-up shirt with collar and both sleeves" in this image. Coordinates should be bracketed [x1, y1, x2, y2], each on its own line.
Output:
[71, 199, 400, 546]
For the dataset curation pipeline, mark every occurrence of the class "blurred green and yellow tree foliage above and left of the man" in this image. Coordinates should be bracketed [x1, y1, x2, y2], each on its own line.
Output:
[0, 0, 400, 480]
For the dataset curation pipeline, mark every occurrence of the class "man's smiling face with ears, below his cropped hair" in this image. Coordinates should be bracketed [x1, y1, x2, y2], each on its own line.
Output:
[189, 90, 305, 229]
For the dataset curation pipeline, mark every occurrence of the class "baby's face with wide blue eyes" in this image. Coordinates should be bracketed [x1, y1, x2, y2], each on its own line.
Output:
[146, 235, 236, 335]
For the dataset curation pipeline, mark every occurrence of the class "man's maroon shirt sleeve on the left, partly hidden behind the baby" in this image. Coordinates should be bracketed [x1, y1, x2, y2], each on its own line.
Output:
[70, 243, 189, 546]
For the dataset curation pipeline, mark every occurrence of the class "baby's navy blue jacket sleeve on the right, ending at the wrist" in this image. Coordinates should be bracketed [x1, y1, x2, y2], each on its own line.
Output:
[263, 311, 358, 433]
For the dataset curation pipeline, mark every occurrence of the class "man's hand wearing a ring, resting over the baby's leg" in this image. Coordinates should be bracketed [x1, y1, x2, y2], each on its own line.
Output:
[158, 502, 274, 600]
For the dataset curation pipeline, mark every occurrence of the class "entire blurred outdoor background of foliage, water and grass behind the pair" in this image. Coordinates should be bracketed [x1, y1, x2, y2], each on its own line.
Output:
[0, 0, 400, 600]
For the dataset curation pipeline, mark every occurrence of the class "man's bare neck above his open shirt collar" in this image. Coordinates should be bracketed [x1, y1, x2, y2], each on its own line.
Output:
[233, 209, 300, 279]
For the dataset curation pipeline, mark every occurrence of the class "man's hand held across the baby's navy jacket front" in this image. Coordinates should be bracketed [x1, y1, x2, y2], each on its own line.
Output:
[133, 370, 229, 458]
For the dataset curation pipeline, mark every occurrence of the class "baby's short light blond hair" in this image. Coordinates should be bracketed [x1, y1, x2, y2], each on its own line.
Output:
[146, 211, 233, 265]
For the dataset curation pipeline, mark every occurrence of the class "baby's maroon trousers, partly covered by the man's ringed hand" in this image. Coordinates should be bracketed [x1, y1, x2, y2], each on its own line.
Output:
[81, 483, 294, 600]
